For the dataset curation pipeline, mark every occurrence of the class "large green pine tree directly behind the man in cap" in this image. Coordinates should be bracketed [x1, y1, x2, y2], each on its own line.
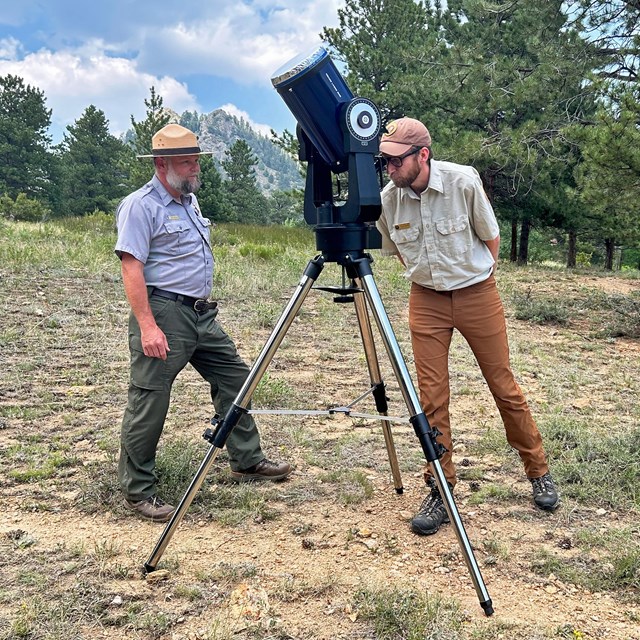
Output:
[325, 0, 596, 262]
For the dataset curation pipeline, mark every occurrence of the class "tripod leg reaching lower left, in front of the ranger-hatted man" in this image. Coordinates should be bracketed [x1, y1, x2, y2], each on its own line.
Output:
[144, 256, 325, 571]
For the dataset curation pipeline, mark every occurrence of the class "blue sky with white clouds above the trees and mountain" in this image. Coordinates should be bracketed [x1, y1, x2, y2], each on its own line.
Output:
[0, 0, 343, 142]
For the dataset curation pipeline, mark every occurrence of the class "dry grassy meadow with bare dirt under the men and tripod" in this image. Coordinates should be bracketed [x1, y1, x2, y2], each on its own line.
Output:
[0, 214, 640, 640]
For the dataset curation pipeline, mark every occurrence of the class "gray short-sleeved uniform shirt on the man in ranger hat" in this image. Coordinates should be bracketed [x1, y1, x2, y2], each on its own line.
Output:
[115, 175, 214, 298]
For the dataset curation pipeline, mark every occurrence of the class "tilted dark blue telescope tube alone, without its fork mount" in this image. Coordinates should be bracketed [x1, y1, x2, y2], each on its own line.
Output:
[271, 47, 353, 173]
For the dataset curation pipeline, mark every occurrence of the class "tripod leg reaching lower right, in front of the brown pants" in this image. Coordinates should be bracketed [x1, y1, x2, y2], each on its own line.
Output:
[352, 257, 493, 616]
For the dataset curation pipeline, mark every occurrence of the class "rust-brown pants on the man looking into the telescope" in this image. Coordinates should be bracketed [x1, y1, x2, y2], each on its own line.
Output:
[409, 276, 549, 485]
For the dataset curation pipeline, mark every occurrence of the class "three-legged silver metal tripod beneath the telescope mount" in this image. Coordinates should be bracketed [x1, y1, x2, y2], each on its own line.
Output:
[144, 250, 493, 616]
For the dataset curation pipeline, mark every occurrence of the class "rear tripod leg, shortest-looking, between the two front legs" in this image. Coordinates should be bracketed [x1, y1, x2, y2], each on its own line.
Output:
[353, 279, 404, 494]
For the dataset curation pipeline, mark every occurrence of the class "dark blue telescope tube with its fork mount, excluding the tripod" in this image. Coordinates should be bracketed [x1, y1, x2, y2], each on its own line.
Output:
[271, 47, 381, 262]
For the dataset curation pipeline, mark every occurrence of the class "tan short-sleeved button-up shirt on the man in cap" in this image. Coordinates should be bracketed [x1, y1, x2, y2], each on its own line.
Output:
[377, 160, 500, 291]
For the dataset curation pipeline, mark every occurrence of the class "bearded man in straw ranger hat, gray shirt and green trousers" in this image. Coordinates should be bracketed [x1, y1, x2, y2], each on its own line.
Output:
[115, 124, 291, 522]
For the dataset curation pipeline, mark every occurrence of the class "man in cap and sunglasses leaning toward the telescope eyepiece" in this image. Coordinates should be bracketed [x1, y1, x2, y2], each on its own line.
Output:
[378, 118, 559, 535]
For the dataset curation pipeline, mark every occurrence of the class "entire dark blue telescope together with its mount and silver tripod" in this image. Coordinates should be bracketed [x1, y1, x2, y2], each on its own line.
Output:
[144, 47, 493, 616]
